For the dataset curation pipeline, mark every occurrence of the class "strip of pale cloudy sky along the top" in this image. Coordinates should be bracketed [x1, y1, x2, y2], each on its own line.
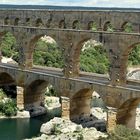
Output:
[0, 0, 140, 8]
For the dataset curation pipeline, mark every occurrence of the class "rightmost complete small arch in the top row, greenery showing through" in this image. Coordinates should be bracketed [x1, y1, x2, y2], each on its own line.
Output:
[121, 22, 133, 33]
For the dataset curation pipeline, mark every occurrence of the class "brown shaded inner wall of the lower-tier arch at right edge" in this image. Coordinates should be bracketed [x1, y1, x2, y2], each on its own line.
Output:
[116, 98, 140, 128]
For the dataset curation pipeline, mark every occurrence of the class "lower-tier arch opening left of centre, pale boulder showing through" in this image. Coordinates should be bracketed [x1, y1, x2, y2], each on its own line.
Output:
[25, 80, 61, 117]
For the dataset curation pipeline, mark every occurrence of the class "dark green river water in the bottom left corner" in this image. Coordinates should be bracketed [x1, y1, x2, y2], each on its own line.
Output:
[0, 114, 53, 140]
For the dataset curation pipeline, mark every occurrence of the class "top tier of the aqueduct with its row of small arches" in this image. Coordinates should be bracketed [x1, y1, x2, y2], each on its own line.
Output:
[0, 10, 140, 32]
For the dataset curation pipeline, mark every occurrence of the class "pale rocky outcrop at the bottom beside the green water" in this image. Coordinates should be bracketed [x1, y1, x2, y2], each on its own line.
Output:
[26, 117, 107, 140]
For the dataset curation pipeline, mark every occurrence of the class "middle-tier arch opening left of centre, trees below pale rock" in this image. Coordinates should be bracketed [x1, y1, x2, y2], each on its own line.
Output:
[33, 35, 64, 68]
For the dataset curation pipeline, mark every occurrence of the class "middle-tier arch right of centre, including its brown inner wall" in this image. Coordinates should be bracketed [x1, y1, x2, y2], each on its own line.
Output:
[72, 37, 110, 74]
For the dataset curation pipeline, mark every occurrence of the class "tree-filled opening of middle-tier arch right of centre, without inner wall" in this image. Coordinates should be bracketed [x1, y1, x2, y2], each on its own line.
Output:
[80, 39, 109, 74]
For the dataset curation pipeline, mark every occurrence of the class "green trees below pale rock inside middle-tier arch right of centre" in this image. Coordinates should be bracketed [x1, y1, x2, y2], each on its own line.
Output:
[80, 43, 109, 74]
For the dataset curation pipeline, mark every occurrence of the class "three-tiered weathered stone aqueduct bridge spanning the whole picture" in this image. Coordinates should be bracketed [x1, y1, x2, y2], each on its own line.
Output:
[0, 10, 140, 128]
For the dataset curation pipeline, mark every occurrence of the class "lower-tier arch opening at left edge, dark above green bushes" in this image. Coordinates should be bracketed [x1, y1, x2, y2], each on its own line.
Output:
[0, 72, 17, 116]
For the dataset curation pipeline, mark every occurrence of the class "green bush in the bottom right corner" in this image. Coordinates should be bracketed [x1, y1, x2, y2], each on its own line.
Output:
[99, 125, 140, 140]
